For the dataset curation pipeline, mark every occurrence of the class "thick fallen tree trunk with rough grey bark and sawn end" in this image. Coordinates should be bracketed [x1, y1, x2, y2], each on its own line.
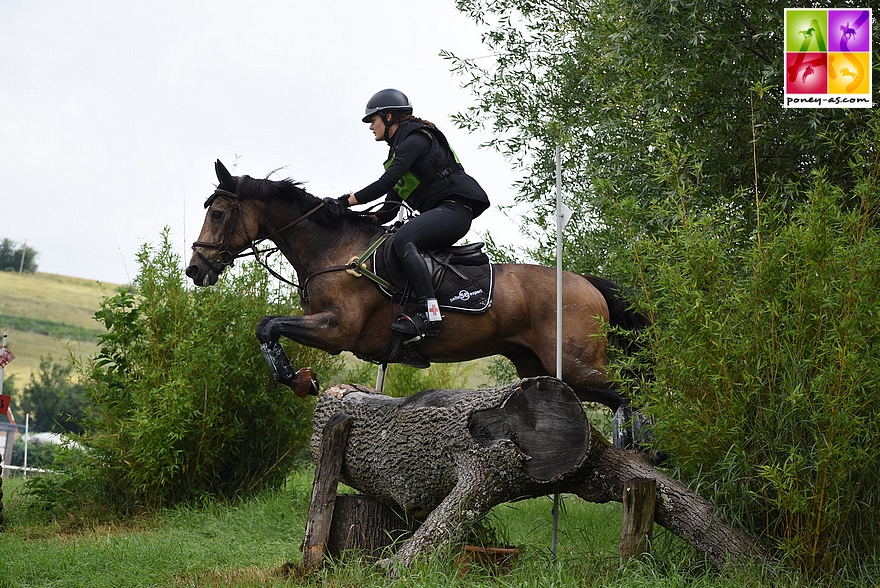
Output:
[312, 378, 758, 566]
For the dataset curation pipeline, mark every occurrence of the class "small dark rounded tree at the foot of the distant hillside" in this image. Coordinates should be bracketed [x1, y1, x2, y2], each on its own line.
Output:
[21, 356, 87, 433]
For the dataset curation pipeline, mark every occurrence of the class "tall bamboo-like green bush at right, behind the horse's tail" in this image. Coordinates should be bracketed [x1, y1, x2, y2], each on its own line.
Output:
[621, 116, 880, 574]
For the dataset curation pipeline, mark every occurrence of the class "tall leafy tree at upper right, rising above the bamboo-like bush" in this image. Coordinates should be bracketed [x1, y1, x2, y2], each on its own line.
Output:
[447, 0, 876, 274]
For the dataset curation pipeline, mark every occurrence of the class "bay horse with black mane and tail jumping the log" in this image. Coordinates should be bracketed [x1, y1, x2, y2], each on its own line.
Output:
[186, 160, 647, 411]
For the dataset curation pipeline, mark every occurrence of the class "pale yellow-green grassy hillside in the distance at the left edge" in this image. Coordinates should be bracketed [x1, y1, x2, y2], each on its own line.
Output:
[0, 272, 118, 390]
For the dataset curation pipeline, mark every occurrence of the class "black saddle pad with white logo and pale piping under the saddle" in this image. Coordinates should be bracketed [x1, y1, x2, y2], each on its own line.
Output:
[372, 237, 495, 313]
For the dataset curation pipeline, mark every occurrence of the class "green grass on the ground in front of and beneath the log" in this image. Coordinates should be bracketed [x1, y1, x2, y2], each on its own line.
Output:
[0, 471, 820, 588]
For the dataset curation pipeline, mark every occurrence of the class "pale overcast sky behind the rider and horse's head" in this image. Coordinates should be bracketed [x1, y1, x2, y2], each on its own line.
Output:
[0, 0, 519, 283]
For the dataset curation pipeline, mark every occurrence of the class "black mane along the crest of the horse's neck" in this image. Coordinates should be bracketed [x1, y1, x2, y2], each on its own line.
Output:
[237, 176, 376, 230]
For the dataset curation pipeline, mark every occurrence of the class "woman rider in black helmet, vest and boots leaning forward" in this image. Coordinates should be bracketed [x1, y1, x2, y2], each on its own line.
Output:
[338, 89, 489, 340]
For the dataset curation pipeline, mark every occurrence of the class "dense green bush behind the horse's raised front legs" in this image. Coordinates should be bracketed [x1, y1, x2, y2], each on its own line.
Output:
[25, 230, 341, 513]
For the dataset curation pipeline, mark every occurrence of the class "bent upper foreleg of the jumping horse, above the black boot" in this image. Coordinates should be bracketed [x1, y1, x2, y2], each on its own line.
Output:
[257, 311, 348, 354]
